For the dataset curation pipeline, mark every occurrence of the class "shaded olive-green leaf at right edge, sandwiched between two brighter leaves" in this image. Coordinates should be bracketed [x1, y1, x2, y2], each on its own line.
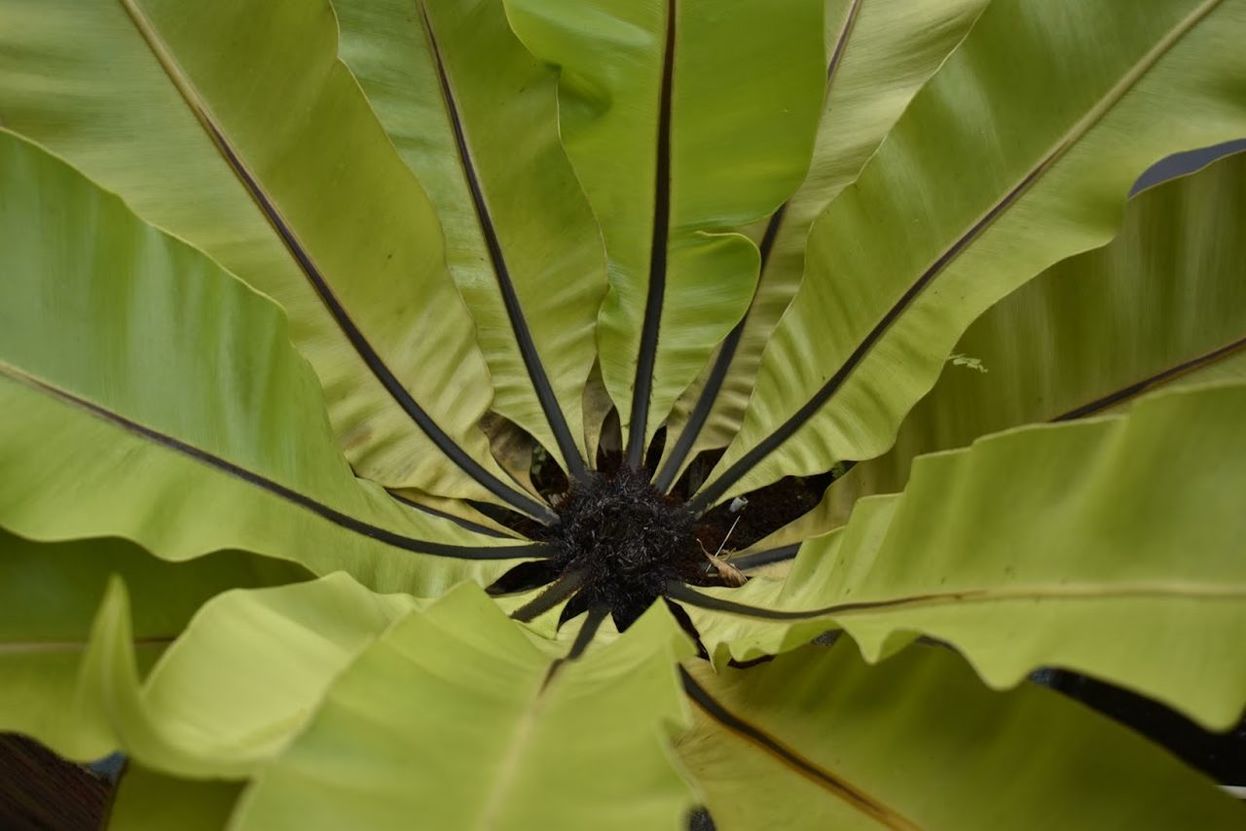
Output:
[754, 154, 1246, 549]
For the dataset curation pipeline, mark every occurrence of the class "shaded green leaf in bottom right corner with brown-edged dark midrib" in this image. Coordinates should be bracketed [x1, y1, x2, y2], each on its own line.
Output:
[679, 642, 1246, 831]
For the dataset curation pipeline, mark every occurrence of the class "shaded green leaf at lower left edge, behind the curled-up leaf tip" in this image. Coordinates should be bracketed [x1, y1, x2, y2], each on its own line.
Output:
[0, 531, 307, 761]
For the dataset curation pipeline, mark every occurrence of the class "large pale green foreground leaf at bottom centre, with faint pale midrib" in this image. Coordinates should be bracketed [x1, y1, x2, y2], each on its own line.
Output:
[233, 587, 693, 831]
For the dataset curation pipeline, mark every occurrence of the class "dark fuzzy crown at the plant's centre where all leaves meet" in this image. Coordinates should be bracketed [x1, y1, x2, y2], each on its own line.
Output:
[548, 466, 708, 629]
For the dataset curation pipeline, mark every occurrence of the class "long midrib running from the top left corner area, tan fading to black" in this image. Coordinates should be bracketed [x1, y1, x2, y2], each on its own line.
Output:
[120, 0, 557, 523]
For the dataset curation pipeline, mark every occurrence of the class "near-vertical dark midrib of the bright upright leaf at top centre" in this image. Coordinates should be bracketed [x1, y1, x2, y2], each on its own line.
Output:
[627, 0, 678, 470]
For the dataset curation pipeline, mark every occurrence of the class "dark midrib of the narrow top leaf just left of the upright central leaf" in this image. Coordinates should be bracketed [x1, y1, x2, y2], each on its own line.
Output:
[419, 0, 588, 481]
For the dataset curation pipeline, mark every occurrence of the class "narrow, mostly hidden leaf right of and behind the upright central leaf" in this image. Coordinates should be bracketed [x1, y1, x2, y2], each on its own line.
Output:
[658, 0, 986, 486]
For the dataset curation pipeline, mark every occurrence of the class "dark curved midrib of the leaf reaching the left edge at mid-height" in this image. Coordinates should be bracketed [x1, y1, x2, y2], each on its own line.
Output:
[0, 365, 546, 559]
